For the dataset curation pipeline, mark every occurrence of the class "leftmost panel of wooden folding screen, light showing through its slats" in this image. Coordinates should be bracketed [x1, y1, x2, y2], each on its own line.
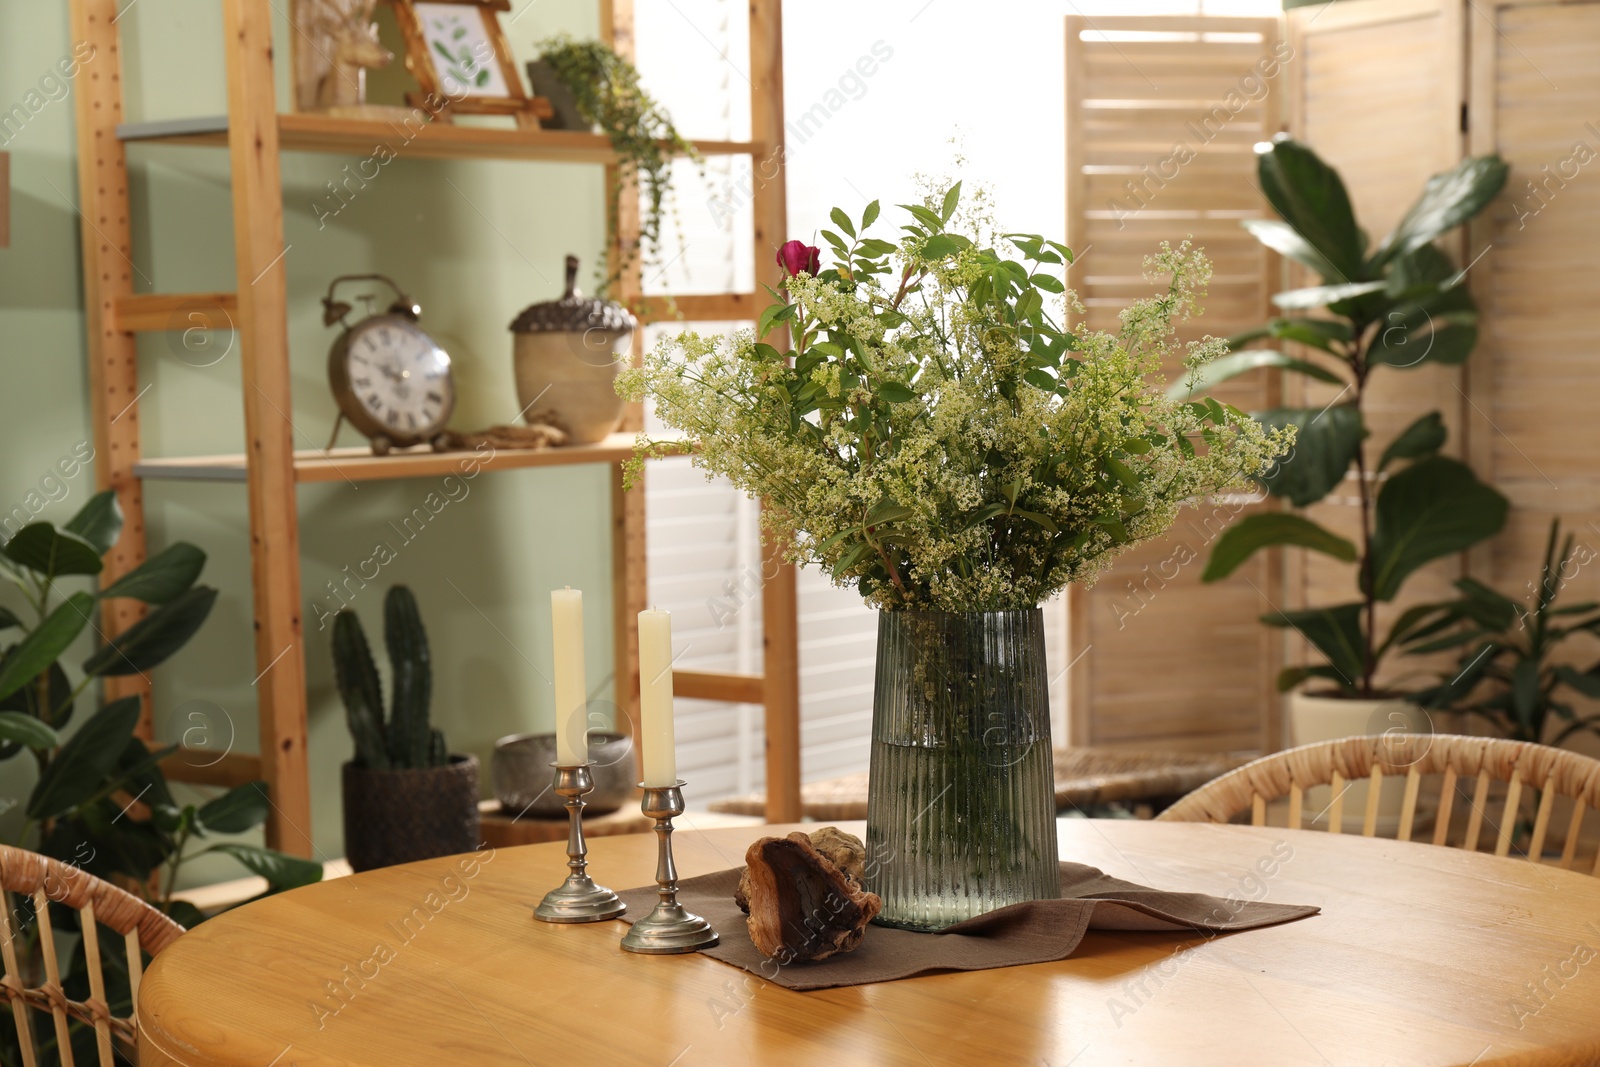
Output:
[1066, 16, 1283, 749]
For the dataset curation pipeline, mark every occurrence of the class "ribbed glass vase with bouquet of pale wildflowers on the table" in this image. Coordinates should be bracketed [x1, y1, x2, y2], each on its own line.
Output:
[619, 184, 1293, 929]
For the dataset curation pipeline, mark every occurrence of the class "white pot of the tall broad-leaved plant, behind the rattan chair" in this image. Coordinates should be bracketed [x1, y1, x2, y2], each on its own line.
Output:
[1288, 689, 1432, 838]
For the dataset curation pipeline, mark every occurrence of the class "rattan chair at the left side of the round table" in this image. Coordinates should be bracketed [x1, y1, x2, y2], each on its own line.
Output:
[0, 845, 184, 1067]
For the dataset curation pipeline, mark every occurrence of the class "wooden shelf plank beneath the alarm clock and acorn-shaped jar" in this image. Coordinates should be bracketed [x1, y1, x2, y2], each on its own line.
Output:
[133, 434, 682, 482]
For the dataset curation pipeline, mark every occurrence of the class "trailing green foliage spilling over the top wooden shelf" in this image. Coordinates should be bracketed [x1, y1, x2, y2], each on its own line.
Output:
[539, 34, 702, 291]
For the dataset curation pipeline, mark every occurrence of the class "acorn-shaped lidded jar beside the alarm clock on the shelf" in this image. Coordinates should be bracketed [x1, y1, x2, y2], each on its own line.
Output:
[510, 256, 637, 445]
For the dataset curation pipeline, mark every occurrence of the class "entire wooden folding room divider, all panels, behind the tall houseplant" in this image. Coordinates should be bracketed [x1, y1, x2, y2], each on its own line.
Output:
[1066, 0, 1600, 767]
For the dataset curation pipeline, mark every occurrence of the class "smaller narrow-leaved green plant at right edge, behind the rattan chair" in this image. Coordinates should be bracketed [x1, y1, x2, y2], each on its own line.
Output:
[1403, 518, 1600, 745]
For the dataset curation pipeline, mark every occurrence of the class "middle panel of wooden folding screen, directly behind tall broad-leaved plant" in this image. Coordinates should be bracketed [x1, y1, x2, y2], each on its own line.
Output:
[1286, 0, 1478, 697]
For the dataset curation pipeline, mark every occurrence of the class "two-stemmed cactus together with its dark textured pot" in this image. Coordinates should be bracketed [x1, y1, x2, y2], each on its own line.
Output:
[333, 585, 478, 870]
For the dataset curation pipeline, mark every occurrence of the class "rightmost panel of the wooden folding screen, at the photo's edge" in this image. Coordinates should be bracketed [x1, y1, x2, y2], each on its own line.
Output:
[1467, 0, 1600, 752]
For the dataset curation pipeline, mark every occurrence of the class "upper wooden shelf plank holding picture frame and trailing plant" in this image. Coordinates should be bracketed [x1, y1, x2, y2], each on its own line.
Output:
[117, 114, 762, 163]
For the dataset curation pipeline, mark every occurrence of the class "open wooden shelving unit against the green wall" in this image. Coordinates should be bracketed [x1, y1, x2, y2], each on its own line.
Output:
[72, 0, 800, 856]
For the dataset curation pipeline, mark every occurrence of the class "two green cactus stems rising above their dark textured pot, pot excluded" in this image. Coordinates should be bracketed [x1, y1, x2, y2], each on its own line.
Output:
[333, 585, 450, 771]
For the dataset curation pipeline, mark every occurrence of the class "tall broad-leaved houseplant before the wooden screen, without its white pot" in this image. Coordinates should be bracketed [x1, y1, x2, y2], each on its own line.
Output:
[1203, 138, 1507, 699]
